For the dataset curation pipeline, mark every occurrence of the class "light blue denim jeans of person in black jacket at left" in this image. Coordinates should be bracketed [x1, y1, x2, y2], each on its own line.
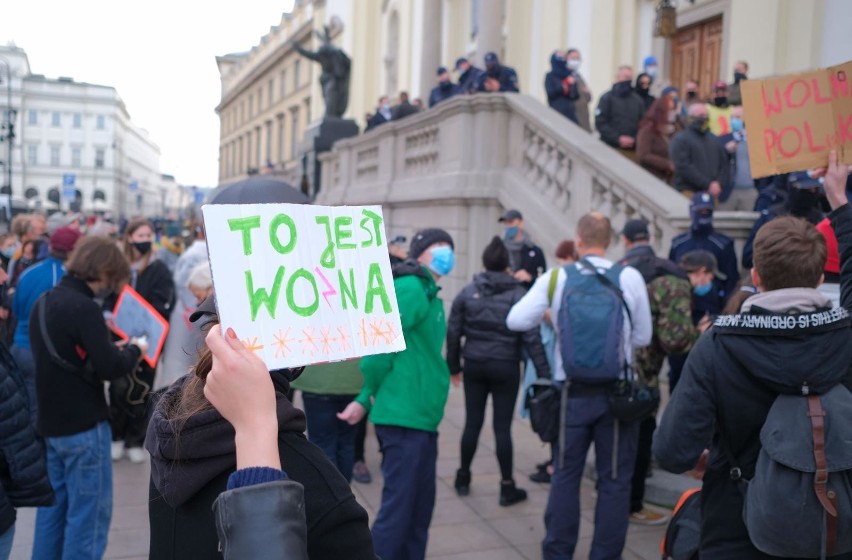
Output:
[33, 421, 112, 560]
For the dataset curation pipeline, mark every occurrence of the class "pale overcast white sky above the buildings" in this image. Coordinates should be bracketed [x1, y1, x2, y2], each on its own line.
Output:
[0, 0, 293, 186]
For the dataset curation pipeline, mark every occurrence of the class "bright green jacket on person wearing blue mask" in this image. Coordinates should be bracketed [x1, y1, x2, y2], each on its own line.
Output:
[355, 269, 450, 432]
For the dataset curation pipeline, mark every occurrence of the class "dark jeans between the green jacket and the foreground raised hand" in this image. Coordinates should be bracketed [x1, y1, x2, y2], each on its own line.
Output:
[302, 392, 357, 482]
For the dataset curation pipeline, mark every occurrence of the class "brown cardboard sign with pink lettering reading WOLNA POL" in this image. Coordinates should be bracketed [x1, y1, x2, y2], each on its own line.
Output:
[740, 62, 852, 179]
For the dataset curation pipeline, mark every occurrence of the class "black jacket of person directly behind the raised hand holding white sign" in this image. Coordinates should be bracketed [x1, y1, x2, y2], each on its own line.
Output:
[145, 373, 376, 560]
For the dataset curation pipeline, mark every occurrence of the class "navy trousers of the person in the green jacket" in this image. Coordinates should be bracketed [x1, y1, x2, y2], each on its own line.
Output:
[373, 426, 438, 560]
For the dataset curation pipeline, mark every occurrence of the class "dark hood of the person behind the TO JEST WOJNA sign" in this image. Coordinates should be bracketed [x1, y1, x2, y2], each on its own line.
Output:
[145, 374, 305, 507]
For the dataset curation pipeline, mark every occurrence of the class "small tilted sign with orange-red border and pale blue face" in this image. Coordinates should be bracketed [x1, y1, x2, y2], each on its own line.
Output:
[112, 286, 169, 367]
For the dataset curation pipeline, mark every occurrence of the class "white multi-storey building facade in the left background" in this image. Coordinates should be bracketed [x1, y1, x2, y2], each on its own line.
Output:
[0, 47, 165, 216]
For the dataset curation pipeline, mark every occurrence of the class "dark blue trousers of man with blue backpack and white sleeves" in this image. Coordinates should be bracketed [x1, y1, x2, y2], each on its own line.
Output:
[542, 395, 639, 560]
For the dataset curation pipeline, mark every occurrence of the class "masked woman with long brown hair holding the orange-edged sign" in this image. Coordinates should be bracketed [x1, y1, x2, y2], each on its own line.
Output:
[107, 219, 175, 463]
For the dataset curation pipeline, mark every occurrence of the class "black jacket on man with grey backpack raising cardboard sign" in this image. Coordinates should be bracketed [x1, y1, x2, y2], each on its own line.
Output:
[653, 204, 852, 560]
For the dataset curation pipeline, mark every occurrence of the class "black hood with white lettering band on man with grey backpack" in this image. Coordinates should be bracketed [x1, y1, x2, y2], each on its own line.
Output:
[711, 288, 852, 395]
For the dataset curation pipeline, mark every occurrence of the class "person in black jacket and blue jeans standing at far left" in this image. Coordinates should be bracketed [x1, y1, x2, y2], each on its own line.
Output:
[29, 237, 148, 560]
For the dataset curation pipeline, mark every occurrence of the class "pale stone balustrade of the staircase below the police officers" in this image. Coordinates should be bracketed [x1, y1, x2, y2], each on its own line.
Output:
[317, 94, 754, 293]
